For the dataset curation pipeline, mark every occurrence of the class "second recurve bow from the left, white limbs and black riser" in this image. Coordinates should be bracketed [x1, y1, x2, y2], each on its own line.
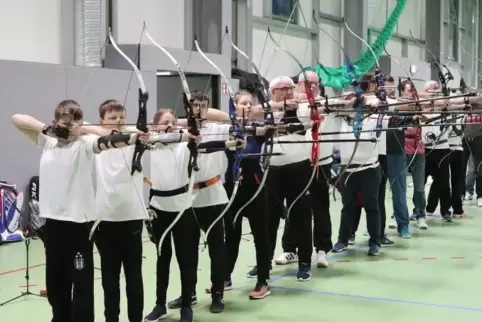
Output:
[144, 22, 199, 255]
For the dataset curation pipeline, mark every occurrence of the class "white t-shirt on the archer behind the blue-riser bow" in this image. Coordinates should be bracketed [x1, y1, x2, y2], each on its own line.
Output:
[339, 115, 379, 172]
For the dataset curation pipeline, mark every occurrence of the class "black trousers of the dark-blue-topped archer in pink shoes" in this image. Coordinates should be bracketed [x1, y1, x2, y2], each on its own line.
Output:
[224, 174, 270, 284]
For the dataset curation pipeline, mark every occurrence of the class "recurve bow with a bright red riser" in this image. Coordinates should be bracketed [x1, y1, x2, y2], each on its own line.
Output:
[268, 28, 320, 219]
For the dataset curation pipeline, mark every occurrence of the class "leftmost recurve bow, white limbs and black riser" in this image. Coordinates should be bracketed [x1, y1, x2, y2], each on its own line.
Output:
[89, 28, 149, 239]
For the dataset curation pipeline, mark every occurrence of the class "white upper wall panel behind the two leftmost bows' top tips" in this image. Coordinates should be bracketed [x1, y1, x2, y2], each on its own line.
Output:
[114, 0, 184, 48]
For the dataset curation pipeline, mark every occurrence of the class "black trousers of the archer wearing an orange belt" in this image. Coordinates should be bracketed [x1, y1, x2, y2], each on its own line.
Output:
[194, 205, 226, 295]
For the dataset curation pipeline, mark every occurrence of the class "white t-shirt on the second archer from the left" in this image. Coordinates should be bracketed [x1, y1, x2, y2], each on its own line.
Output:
[95, 146, 148, 221]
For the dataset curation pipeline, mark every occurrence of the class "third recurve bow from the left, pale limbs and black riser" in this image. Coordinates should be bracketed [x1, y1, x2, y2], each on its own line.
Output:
[194, 37, 244, 240]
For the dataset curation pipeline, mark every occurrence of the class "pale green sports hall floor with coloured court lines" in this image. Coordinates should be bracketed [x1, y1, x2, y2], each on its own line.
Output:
[0, 184, 482, 322]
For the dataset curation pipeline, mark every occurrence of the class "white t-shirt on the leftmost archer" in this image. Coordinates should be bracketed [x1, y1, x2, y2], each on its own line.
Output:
[37, 134, 98, 223]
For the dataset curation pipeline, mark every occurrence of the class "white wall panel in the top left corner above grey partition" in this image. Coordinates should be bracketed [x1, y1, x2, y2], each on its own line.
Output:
[0, 0, 64, 64]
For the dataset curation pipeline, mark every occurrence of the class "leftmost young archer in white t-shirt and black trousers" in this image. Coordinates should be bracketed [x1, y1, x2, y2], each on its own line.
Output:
[12, 100, 148, 322]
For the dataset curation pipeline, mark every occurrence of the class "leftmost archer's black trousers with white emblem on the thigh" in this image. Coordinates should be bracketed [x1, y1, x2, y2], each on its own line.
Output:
[43, 219, 94, 322]
